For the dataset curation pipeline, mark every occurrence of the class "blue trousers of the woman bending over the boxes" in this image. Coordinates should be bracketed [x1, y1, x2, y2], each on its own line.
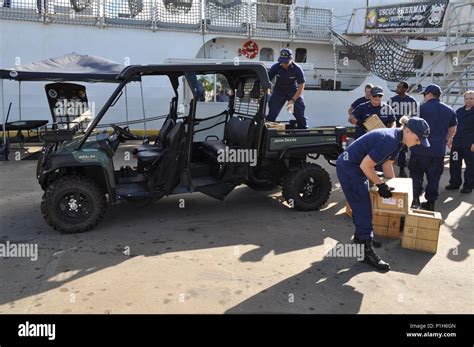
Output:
[336, 159, 374, 240]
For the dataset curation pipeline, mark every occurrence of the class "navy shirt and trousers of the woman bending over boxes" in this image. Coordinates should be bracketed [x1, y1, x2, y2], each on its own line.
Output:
[336, 128, 403, 240]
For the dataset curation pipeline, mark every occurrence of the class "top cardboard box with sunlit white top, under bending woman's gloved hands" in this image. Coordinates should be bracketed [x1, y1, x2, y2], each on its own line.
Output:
[370, 178, 413, 215]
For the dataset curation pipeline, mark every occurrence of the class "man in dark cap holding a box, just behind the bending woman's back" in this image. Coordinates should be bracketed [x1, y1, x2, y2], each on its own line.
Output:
[352, 87, 396, 139]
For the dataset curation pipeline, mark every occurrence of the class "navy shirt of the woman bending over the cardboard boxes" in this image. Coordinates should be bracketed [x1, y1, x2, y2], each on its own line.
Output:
[337, 128, 404, 174]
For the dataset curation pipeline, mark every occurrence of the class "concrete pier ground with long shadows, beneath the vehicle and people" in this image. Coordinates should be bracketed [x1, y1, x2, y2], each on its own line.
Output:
[0, 150, 474, 314]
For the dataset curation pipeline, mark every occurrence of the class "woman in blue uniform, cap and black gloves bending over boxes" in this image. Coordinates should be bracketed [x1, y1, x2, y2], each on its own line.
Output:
[336, 117, 430, 271]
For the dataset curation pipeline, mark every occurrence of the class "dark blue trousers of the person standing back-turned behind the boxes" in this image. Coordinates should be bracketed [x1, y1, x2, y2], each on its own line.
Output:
[408, 152, 444, 201]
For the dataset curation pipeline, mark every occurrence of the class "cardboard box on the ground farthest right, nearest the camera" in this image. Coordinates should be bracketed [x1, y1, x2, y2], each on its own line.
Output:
[402, 210, 443, 253]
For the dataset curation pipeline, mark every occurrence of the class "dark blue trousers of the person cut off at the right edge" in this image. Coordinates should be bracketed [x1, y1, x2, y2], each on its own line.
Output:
[449, 143, 474, 189]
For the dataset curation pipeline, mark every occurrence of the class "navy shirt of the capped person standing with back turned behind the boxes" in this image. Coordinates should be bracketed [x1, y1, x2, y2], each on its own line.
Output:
[411, 99, 458, 157]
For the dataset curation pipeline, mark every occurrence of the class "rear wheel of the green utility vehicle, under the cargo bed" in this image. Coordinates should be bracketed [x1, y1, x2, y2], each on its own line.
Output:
[283, 163, 332, 211]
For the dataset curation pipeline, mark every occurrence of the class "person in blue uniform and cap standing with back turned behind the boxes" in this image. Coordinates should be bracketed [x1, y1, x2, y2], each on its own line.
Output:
[408, 84, 457, 211]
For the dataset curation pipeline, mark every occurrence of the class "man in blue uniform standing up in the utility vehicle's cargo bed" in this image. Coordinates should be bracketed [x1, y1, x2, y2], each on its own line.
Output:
[267, 48, 308, 129]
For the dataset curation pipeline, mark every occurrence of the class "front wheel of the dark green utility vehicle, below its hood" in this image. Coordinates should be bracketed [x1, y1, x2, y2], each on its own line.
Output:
[41, 175, 106, 234]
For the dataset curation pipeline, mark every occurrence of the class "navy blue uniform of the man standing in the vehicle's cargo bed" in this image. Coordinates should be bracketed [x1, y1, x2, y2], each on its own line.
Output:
[267, 63, 308, 129]
